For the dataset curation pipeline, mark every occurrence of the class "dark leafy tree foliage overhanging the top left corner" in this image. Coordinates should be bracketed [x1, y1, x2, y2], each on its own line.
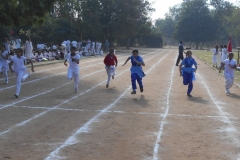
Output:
[0, 0, 64, 27]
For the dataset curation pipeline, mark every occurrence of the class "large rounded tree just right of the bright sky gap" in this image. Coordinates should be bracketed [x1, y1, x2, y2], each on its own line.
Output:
[174, 0, 218, 49]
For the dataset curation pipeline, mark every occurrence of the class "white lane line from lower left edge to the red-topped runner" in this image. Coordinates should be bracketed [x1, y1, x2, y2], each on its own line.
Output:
[0, 51, 163, 136]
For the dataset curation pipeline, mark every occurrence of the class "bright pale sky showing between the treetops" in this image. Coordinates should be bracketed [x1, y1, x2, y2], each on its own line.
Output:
[148, 0, 236, 20]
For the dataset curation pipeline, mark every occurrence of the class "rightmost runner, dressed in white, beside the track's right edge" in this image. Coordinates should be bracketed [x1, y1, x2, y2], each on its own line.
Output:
[219, 53, 237, 95]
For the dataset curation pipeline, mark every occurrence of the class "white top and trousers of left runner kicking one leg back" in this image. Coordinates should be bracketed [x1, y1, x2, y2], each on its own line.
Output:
[11, 56, 30, 96]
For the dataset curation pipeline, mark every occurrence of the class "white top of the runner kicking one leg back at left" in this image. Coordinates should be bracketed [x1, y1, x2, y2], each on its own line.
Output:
[11, 55, 26, 73]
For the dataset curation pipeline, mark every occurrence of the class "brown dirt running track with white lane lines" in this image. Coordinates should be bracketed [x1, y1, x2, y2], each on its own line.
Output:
[0, 49, 240, 160]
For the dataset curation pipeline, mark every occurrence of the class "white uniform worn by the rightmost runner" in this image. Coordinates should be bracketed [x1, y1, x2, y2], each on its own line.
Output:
[223, 59, 237, 89]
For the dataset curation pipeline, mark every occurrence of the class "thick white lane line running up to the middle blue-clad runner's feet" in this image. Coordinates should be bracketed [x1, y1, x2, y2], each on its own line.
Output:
[45, 53, 169, 160]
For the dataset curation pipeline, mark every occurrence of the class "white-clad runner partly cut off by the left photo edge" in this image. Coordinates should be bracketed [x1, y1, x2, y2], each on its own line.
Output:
[0, 45, 8, 84]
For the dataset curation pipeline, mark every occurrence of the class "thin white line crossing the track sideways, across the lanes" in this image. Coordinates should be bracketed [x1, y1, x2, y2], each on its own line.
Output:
[12, 105, 239, 119]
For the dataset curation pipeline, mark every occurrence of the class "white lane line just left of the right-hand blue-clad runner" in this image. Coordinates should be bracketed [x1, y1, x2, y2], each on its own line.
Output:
[153, 59, 175, 160]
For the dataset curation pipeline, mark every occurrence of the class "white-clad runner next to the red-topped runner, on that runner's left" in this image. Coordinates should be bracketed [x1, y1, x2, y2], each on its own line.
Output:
[64, 47, 80, 92]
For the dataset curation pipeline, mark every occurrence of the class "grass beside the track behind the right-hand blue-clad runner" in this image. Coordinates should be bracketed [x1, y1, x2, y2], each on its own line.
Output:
[193, 50, 240, 84]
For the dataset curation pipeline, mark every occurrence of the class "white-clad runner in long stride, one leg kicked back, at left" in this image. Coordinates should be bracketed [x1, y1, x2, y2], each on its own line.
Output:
[9, 49, 34, 98]
